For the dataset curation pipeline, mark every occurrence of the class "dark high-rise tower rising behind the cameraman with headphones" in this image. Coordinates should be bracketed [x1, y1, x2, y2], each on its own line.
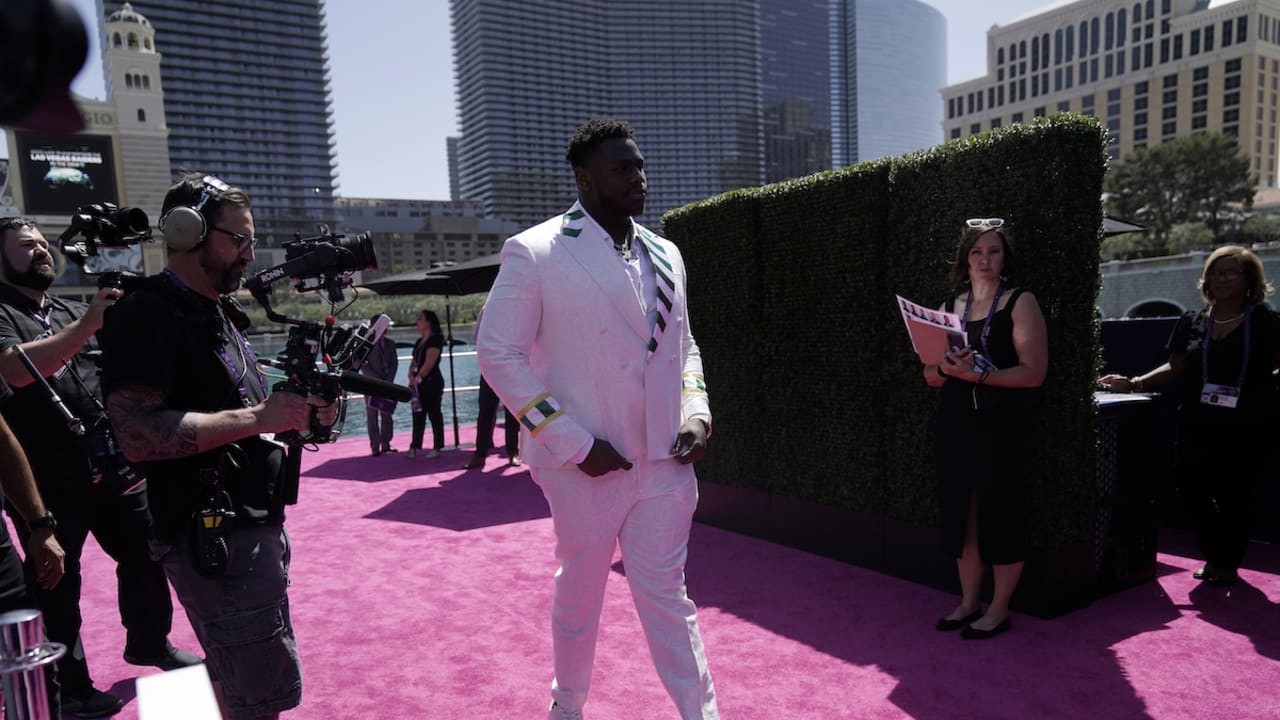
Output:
[102, 0, 334, 246]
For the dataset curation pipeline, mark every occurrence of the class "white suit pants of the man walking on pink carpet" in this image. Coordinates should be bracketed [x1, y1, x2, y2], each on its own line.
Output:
[532, 460, 719, 720]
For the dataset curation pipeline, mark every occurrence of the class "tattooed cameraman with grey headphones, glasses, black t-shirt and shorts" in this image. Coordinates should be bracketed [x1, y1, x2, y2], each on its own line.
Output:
[102, 174, 338, 720]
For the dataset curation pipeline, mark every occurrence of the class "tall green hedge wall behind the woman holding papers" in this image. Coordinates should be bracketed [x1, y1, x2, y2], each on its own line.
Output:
[663, 114, 1106, 547]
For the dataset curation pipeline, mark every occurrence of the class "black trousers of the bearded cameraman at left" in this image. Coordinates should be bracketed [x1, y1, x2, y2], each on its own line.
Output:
[8, 475, 173, 696]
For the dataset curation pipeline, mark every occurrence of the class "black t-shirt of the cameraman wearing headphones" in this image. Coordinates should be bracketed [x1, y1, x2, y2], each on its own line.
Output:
[101, 274, 284, 541]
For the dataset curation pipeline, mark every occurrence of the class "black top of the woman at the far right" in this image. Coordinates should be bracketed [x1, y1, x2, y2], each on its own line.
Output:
[1167, 305, 1280, 424]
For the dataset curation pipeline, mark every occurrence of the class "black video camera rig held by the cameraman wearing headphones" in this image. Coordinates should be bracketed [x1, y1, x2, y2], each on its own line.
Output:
[244, 225, 410, 457]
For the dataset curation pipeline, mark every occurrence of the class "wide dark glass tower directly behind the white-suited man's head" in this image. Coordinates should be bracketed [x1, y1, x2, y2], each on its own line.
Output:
[452, 0, 764, 225]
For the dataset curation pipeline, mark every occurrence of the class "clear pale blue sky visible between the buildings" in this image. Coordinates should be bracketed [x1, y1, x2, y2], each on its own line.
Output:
[64, 0, 1055, 200]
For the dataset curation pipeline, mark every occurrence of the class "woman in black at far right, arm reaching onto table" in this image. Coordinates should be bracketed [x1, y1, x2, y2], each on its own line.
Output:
[1098, 245, 1280, 585]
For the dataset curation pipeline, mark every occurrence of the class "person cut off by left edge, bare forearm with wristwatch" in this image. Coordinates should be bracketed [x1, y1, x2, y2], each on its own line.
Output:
[0, 366, 65, 720]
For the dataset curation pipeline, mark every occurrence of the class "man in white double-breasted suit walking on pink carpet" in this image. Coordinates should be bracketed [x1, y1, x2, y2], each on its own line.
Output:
[476, 119, 719, 720]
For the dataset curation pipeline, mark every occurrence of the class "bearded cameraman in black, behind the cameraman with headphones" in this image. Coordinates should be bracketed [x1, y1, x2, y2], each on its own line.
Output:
[0, 218, 200, 717]
